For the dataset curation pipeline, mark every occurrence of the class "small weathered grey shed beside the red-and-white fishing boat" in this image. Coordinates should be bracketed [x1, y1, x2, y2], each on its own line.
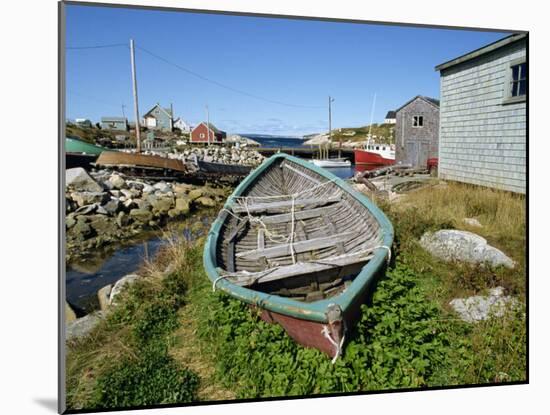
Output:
[395, 95, 439, 167]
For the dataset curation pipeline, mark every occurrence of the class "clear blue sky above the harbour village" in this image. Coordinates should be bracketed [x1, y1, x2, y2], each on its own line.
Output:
[66, 5, 507, 135]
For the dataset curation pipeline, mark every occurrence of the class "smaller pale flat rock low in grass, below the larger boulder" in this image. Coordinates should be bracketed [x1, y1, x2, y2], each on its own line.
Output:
[449, 287, 518, 323]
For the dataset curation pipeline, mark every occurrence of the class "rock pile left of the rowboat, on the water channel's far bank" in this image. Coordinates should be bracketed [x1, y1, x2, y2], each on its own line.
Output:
[65, 168, 228, 259]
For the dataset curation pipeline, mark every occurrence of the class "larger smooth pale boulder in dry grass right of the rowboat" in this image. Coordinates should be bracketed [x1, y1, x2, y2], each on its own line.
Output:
[420, 229, 515, 268]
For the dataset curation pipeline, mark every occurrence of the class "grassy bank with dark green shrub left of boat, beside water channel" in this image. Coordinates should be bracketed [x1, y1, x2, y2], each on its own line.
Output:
[67, 232, 203, 409]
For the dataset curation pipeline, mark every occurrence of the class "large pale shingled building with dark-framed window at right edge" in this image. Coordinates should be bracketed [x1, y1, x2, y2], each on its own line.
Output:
[435, 34, 527, 193]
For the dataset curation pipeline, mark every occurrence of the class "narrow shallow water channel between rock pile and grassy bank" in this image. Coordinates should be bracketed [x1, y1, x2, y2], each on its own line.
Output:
[66, 214, 213, 314]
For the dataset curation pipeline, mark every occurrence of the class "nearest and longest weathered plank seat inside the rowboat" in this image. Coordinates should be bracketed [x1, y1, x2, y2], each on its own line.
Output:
[224, 252, 373, 287]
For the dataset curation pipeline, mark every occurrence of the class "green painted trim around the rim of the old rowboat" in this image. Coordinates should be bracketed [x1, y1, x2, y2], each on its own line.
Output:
[203, 153, 394, 323]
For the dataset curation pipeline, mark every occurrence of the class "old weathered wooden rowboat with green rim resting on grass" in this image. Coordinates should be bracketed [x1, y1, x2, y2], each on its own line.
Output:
[204, 153, 393, 360]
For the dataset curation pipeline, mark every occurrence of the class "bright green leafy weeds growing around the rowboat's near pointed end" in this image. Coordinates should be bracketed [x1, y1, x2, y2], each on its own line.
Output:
[200, 264, 449, 398]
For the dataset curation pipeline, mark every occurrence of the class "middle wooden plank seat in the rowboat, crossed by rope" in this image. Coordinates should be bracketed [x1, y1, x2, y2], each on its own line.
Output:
[235, 231, 358, 261]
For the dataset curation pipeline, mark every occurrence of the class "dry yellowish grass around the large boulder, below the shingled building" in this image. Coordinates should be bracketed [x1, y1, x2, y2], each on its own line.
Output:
[379, 183, 526, 305]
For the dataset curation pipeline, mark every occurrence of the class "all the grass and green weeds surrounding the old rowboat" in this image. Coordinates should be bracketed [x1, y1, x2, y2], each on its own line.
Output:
[67, 183, 526, 409]
